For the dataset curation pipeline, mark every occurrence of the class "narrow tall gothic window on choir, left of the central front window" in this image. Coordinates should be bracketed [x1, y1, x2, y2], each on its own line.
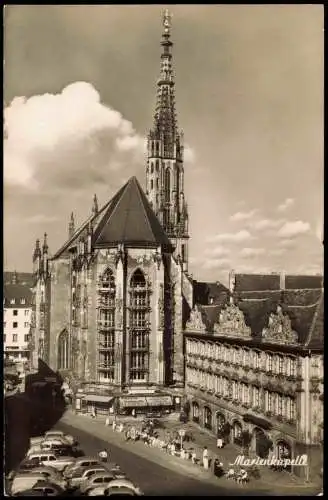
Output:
[98, 268, 116, 381]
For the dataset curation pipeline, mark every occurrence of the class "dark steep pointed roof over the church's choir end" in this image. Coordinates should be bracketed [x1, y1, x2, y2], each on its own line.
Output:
[93, 177, 171, 248]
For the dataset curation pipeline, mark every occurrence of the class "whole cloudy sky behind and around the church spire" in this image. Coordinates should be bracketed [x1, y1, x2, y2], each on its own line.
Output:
[4, 4, 324, 282]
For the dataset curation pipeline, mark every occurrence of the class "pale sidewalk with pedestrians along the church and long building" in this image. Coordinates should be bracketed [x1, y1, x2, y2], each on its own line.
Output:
[61, 411, 319, 495]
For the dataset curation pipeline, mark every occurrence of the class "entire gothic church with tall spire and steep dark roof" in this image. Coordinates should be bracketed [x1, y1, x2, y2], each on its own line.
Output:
[33, 12, 192, 412]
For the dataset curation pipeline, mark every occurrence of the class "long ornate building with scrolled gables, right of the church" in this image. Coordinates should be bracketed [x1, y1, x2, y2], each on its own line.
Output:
[185, 273, 324, 475]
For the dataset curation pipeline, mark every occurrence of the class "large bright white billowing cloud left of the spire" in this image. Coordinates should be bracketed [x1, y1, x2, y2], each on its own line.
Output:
[4, 82, 145, 190]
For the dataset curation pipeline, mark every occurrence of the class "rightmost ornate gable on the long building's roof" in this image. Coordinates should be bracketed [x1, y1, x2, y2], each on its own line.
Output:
[262, 306, 298, 344]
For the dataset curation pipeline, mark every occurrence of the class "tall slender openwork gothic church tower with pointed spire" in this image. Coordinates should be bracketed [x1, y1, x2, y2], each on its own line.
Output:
[146, 10, 189, 271]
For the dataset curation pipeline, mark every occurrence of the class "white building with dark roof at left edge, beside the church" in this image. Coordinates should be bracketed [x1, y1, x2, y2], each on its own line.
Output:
[3, 273, 32, 362]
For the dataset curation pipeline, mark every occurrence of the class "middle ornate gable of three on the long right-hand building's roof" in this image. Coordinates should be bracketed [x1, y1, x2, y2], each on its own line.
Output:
[214, 303, 252, 338]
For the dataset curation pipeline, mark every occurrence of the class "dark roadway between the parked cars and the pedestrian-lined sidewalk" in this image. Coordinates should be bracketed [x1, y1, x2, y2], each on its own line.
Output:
[56, 422, 263, 496]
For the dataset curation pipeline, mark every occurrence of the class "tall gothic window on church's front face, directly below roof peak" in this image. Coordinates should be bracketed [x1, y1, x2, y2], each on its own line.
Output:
[129, 269, 149, 382]
